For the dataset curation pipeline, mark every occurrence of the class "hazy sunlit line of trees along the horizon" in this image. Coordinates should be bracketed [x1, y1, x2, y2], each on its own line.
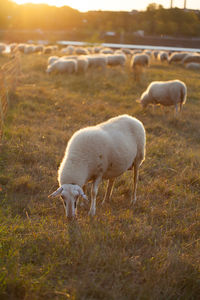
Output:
[0, 0, 200, 37]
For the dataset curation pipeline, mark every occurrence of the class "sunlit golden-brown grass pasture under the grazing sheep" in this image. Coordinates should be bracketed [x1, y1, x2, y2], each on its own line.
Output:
[0, 55, 200, 300]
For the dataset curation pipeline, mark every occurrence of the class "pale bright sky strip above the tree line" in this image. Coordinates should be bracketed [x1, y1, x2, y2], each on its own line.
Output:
[13, 0, 200, 12]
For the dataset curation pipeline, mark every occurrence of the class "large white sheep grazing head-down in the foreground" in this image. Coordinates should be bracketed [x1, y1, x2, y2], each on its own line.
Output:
[49, 115, 146, 217]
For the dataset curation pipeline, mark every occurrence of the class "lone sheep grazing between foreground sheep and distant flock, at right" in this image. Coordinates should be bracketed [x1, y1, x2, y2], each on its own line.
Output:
[137, 80, 187, 114]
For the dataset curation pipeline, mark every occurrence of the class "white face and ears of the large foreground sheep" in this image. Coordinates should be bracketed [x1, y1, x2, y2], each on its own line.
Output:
[49, 184, 87, 218]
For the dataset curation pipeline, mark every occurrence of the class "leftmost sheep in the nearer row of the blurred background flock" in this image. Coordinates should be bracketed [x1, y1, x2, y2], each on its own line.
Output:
[46, 58, 77, 74]
